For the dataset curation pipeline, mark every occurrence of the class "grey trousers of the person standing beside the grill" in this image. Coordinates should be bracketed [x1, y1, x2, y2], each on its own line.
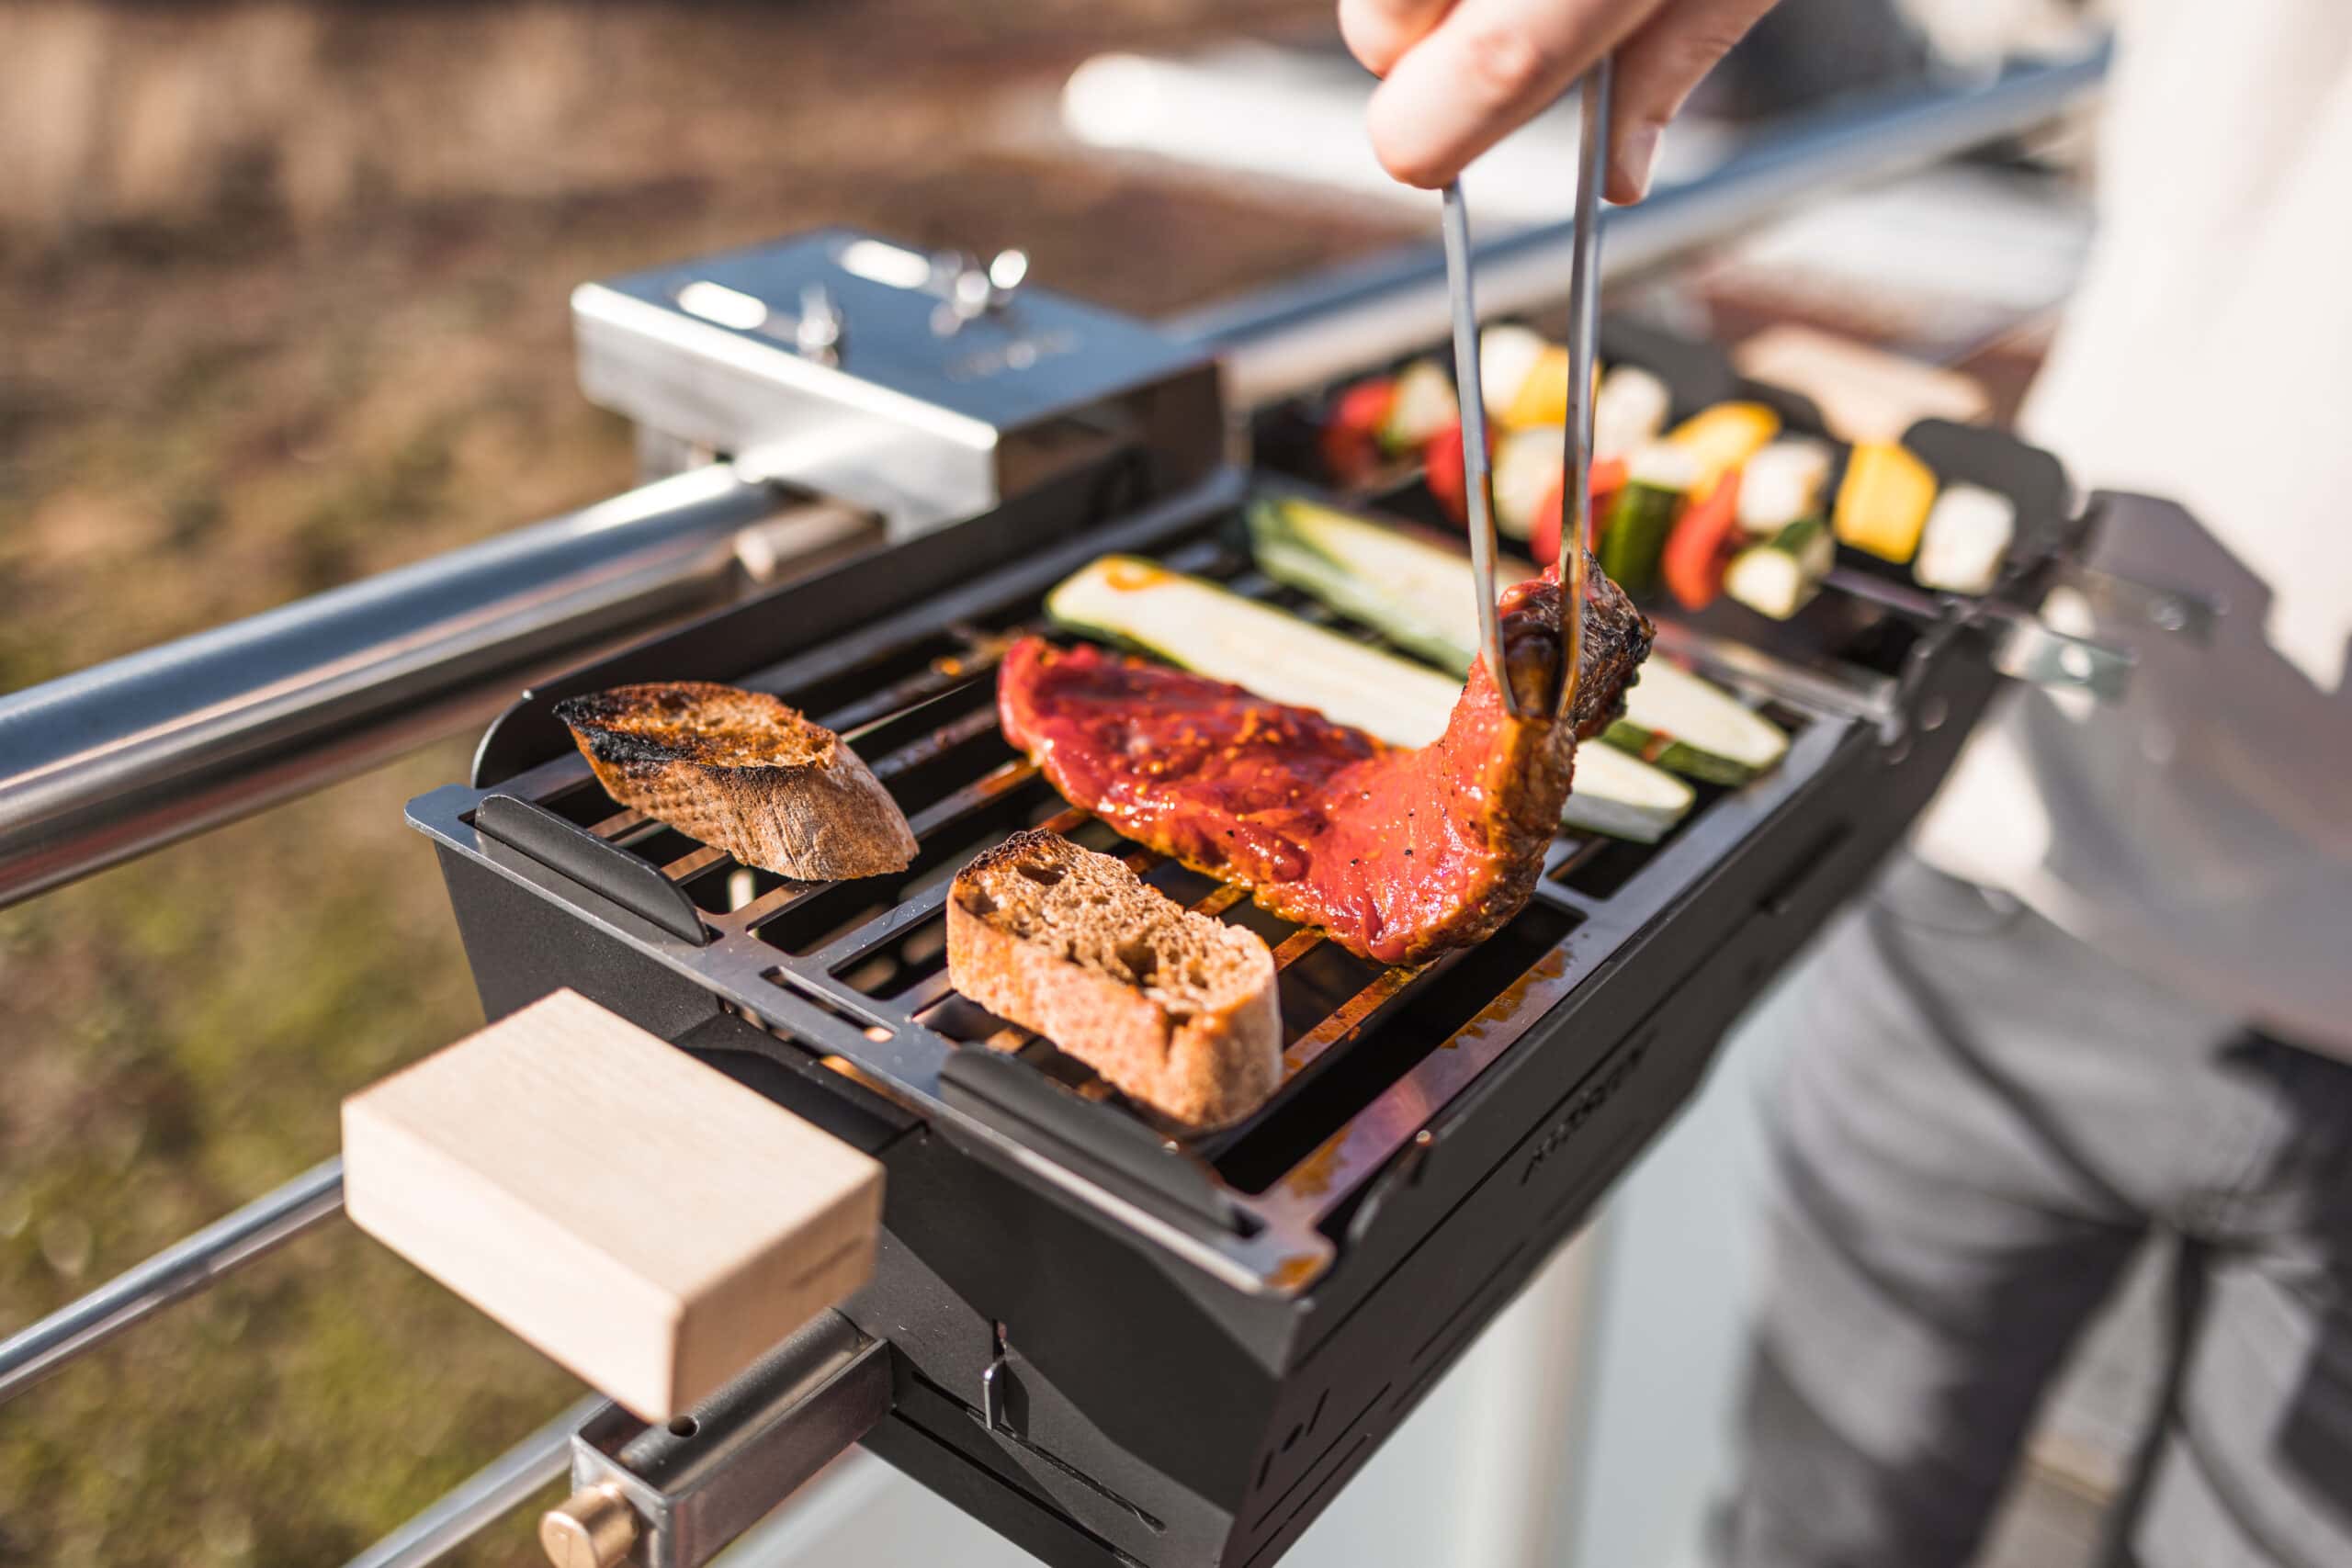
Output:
[1724, 858, 2352, 1568]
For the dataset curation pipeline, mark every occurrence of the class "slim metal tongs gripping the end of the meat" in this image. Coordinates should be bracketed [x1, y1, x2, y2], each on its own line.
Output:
[1440, 54, 1611, 719]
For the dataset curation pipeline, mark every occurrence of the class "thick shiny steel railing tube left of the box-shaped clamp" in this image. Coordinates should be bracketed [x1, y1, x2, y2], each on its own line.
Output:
[0, 466, 858, 905]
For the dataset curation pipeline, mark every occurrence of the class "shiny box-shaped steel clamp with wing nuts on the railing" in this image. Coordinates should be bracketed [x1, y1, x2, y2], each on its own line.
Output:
[571, 228, 1223, 543]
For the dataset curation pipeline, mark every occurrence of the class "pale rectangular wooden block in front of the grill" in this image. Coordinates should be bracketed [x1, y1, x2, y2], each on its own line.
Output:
[344, 989, 882, 1422]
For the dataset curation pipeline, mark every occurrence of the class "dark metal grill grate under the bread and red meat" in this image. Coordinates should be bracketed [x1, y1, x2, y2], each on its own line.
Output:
[425, 495, 1847, 1288]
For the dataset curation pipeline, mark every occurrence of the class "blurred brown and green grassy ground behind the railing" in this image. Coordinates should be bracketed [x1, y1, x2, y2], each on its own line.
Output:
[0, 0, 1395, 1568]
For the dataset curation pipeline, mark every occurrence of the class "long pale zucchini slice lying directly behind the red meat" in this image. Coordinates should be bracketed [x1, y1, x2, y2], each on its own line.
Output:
[1045, 552, 1693, 844]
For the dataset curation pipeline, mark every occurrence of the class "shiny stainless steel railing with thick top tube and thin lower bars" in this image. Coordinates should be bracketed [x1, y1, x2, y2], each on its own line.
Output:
[0, 50, 2108, 1568]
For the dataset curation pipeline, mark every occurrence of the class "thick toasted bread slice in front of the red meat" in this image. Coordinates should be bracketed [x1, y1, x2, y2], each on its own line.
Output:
[948, 828, 1282, 1128]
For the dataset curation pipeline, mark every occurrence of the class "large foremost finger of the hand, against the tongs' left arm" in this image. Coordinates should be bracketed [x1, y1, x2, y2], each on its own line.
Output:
[1369, 0, 1674, 190]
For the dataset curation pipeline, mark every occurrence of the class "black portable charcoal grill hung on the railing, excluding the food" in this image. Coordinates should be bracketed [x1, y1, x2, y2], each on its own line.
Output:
[371, 220, 2096, 1568]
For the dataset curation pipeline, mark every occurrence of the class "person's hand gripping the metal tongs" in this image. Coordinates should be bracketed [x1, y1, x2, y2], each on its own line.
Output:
[1339, 0, 1773, 202]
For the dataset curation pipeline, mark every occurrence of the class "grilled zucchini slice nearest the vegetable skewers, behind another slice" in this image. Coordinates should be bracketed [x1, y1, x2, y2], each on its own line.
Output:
[1249, 499, 1788, 785]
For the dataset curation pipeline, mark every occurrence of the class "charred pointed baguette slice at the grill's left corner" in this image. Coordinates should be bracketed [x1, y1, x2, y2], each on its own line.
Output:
[555, 682, 915, 882]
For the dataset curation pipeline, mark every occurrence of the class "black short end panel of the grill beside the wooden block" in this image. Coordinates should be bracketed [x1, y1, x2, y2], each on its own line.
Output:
[844, 1104, 1303, 1563]
